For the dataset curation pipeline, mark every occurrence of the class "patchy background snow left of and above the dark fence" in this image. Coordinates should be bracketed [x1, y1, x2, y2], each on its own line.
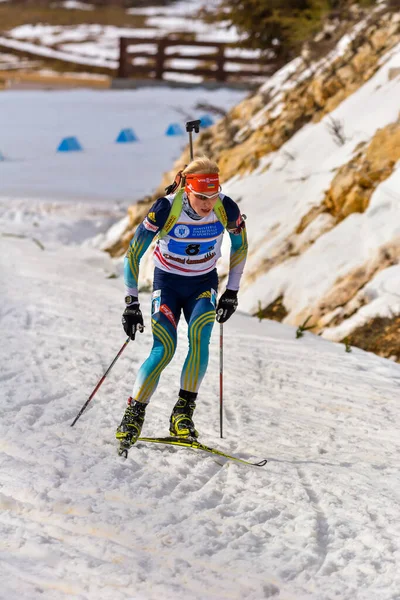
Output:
[0, 0, 241, 75]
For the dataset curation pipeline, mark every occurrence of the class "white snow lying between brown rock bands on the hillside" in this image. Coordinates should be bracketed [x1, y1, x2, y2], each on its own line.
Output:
[223, 40, 400, 339]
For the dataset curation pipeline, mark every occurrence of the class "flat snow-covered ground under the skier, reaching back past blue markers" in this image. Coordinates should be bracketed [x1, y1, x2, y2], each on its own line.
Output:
[0, 83, 400, 600]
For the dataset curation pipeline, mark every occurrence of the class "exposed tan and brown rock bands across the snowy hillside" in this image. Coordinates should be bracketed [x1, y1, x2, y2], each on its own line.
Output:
[108, 8, 400, 361]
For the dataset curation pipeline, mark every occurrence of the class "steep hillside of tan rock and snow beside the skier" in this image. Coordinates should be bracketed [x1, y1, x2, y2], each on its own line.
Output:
[104, 4, 400, 361]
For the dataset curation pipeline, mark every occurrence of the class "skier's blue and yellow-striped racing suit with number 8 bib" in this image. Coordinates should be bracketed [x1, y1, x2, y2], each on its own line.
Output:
[124, 193, 247, 403]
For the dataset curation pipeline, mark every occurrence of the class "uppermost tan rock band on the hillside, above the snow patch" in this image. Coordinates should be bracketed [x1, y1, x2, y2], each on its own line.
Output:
[183, 8, 400, 180]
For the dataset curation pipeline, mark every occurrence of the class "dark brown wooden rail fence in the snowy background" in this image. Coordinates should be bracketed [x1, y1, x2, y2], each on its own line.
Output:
[117, 37, 279, 82]
